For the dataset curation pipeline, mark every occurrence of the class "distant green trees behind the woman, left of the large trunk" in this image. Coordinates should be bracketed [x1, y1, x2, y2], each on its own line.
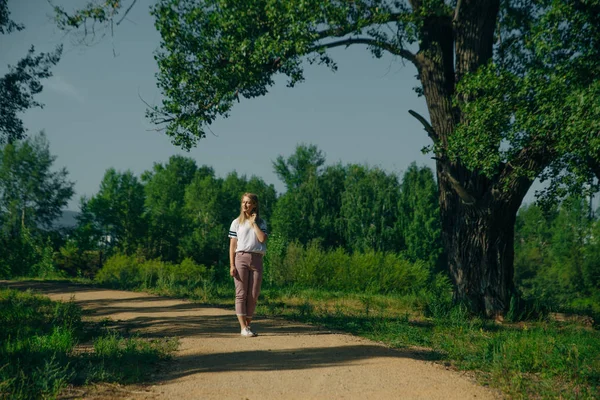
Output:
[0, 138, 441, 275]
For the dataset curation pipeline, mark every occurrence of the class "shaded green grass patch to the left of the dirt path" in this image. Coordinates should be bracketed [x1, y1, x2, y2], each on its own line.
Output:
[0, 289, 177, 399]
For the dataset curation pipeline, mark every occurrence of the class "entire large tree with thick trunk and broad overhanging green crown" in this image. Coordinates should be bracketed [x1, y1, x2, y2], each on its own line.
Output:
[56, 0, 600, 316]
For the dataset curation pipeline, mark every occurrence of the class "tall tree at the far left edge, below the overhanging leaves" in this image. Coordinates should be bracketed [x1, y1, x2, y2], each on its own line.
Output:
[0, 133, 74, 277]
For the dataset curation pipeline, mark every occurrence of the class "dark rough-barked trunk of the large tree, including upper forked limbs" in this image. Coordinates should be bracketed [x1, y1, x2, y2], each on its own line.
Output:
[416, 0, 532, 317]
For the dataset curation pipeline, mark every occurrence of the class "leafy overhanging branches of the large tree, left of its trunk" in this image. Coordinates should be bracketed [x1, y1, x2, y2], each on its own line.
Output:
[147, 0, 408, 148]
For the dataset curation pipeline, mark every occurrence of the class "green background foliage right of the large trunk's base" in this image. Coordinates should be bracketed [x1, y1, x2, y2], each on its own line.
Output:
[515, 197, 600, 315]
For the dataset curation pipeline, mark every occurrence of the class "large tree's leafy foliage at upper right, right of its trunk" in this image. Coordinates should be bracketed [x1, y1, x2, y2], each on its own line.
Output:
[448, 0, 600, 199]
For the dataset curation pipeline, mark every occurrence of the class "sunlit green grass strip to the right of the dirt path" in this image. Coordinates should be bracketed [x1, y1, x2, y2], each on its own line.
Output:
[257, 289, 600, 399]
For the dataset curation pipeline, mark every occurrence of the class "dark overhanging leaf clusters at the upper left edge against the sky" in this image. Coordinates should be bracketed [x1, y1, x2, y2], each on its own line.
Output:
[0, 0, 62, 144]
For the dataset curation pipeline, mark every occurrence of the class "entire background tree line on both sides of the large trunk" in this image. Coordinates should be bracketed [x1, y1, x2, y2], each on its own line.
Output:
[0, 133, 600, 312]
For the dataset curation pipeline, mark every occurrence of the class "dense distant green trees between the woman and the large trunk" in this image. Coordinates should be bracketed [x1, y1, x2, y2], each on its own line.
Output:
[273, 145, 442, 268]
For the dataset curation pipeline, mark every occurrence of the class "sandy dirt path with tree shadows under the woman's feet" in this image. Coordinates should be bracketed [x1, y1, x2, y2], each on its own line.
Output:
[0, 282, 498, 400]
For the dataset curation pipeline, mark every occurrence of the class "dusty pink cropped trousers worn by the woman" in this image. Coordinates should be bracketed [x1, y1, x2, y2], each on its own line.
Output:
[233, 251, 263, 318]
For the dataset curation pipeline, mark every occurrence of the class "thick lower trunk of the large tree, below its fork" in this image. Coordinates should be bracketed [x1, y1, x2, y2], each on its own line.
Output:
[440, 178, 530, 317]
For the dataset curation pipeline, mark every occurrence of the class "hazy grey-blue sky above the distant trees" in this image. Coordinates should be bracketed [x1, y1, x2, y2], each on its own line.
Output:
[0, 0, 536, 211]
